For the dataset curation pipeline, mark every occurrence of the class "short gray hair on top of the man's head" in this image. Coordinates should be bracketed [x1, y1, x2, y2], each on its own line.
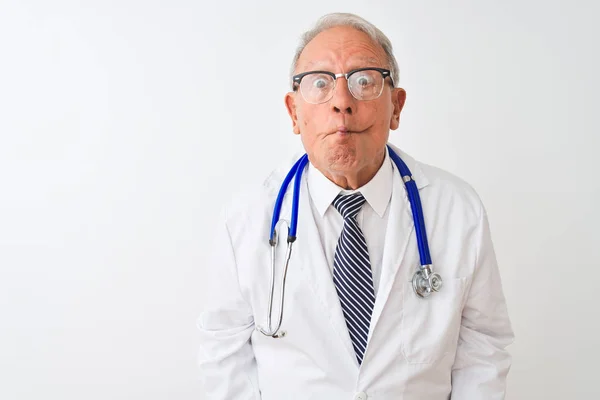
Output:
[290, 13, 400, 85]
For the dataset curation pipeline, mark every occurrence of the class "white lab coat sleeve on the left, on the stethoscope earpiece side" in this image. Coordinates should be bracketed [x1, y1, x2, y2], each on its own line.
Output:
[197, 208, 260, 400]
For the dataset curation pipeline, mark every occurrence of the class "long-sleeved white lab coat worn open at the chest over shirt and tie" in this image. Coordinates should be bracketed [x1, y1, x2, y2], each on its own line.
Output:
[198, 143, 513, 400]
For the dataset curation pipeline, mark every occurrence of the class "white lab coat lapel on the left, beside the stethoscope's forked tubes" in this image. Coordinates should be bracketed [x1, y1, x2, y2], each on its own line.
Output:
[283, 171, 358, 366]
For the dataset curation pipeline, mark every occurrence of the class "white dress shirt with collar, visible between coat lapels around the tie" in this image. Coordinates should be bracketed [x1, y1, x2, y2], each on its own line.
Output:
[306, 148, 394, 295]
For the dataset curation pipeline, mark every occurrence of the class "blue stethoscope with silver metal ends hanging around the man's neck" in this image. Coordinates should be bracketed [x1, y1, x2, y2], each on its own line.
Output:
[257, 145, 442, 338]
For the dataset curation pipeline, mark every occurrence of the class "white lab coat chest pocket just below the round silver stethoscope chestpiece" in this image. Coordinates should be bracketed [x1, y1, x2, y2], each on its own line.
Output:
[400, 278, 466, 364]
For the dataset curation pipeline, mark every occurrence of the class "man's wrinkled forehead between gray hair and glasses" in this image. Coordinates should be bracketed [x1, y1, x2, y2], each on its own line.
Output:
[296, 26, 387, 72]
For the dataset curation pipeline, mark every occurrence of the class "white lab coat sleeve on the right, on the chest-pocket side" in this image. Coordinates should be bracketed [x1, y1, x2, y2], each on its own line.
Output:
[451, 206, 514, 400]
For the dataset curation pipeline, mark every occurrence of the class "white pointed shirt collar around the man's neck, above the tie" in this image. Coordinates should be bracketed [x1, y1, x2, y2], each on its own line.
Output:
[306, 146, 394, 218]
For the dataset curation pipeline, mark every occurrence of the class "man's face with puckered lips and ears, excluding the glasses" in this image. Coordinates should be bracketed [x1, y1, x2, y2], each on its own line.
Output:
[285, 27, 406, 175]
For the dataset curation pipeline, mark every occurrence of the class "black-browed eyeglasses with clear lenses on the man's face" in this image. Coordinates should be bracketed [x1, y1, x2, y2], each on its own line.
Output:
[292, 68, 394, 104]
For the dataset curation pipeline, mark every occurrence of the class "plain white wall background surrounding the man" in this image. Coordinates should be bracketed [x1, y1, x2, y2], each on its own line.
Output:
[0, 0, 600, 400]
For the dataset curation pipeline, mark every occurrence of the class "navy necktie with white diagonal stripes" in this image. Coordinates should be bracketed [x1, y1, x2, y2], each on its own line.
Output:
[333, 193, 375, 365]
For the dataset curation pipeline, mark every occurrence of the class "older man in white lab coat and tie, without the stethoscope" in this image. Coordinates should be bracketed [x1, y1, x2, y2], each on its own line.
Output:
[198, 14, 513, 400]
